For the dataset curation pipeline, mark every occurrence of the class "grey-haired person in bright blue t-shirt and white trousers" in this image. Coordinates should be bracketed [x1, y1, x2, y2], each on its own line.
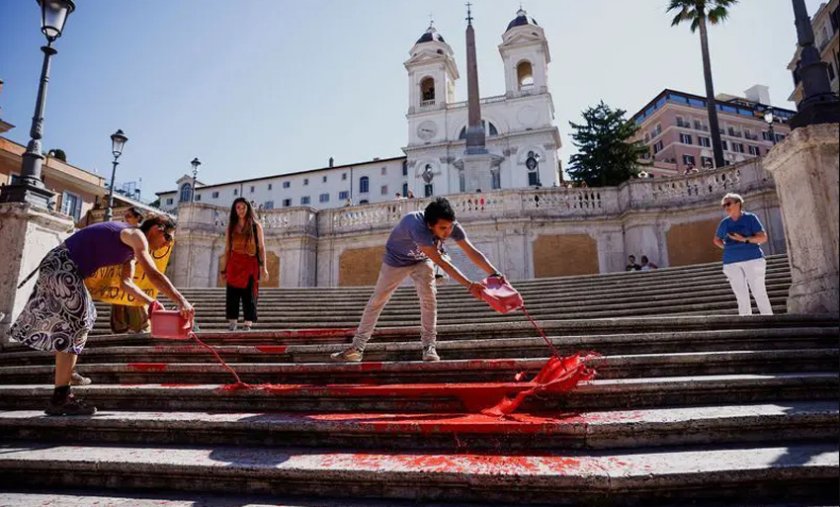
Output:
[712, 193, 773, 315]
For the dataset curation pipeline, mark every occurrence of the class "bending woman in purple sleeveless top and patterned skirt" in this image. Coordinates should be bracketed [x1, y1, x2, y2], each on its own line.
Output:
[9, 217, 194, 415]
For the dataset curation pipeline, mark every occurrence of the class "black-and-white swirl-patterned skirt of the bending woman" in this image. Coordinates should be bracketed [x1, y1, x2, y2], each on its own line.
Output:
[9, 243, 96, 354]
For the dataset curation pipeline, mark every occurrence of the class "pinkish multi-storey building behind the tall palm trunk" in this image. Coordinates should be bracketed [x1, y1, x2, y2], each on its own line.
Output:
[631, 89, 796, 177]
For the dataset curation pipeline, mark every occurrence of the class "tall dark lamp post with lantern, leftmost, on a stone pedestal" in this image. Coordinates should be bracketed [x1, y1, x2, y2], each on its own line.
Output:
[0, 0, 76, 208]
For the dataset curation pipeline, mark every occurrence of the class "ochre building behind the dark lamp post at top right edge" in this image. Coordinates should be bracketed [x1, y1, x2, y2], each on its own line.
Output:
[788, 0, 840, 104]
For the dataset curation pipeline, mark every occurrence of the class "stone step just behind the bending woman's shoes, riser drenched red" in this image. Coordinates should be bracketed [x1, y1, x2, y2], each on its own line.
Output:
[0, 371, 840, 413]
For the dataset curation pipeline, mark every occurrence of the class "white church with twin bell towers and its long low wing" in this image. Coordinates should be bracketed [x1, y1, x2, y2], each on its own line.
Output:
[158, 9, 560, 213]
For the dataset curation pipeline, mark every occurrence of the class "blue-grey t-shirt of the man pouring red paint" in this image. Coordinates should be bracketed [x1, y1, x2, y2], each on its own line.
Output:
[382, 211, 467, 268]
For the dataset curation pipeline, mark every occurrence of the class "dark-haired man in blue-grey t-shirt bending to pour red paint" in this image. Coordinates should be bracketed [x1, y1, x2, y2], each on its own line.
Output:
[330, 197, 502, 362]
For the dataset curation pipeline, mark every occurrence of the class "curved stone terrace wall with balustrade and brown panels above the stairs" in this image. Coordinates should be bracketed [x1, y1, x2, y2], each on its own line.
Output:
[172, 160, 785, 287]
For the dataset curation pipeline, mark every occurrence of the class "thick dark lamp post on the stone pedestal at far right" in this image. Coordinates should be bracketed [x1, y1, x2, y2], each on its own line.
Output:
[790, 0, 840, 130]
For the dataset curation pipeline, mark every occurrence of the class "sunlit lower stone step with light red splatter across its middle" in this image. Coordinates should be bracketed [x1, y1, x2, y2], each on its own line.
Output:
[0, 441, 838, 505]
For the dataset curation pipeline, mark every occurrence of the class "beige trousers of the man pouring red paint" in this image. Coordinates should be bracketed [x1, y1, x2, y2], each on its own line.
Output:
[353, 260, 437, 351]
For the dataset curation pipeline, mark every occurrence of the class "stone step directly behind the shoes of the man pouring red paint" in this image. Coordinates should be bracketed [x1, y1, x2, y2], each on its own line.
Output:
[0, 327, 840, 366]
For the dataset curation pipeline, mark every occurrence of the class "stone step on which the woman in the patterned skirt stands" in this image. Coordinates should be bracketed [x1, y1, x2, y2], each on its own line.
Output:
[0, 401, 840, 452]
